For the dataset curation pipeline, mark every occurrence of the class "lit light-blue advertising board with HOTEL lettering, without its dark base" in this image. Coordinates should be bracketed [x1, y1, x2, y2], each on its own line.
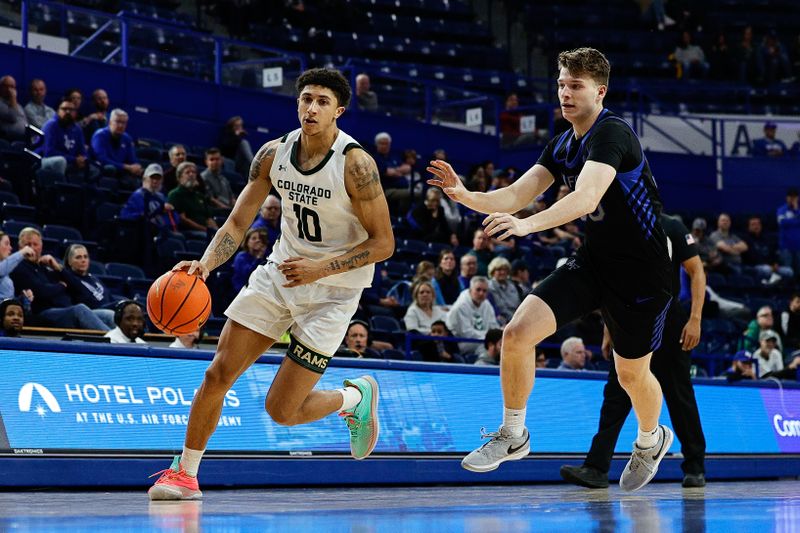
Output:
[0, 346, 800, 455]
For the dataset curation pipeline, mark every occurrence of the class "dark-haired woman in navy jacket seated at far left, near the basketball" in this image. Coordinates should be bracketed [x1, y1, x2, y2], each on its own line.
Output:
[63, 244, 115, 329]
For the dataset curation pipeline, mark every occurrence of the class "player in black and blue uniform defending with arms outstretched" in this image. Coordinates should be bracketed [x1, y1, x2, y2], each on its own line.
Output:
[428, 48, 672, 490]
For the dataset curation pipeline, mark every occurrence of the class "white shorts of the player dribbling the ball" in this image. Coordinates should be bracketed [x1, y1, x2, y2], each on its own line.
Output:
[225, 262, 363, 355]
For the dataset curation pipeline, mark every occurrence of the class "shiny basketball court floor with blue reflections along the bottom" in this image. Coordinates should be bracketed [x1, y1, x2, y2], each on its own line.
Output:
[0, 480, 800, 533]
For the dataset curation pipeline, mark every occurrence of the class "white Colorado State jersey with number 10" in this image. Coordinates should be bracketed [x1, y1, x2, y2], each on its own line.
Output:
[269, 129, 375, 288]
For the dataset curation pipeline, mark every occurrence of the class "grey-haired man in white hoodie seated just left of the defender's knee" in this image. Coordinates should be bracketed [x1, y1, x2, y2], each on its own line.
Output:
[447, 276, 500, 361]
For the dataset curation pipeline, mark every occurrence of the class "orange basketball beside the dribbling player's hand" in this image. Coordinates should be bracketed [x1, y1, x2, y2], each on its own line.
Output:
[147, 270, 211, 335]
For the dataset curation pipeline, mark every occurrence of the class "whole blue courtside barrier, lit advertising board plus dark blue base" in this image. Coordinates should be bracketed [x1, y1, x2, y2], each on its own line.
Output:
[0, 339, 800, 487]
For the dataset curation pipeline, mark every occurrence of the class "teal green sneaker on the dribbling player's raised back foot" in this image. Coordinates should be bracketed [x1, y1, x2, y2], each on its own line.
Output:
[339, 376, 381, 459]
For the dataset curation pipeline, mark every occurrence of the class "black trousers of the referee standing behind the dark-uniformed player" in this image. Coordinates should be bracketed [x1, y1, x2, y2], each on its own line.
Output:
[583, 300, 706, 474]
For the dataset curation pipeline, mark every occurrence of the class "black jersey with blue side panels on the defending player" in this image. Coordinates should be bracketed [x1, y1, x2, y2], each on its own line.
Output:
[538, 109, 670, 279]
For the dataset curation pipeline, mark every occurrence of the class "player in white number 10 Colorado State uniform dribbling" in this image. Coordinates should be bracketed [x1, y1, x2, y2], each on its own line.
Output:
[148, 69, 394, 500]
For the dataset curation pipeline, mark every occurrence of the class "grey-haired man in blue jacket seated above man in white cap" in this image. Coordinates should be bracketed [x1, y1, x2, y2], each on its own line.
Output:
[92, 108, 144, 191]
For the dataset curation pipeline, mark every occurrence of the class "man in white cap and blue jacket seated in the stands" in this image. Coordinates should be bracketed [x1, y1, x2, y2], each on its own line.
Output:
[119, 163, 178, 237]
